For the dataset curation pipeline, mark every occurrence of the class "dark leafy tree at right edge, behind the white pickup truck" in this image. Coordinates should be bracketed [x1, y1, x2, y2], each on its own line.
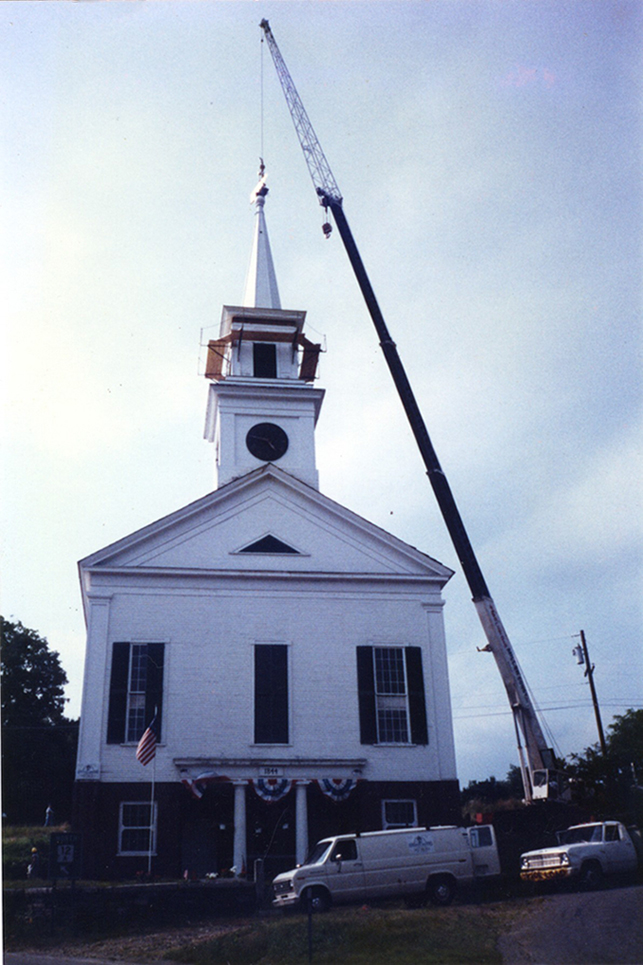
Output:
[566, 709, 643, 821]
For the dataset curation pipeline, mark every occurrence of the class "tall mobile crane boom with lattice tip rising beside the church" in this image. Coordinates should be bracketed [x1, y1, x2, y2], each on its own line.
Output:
[260, 19, 561, 804]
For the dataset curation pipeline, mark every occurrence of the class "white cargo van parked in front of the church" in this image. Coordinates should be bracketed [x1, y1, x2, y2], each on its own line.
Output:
[272, 824, 500, 911]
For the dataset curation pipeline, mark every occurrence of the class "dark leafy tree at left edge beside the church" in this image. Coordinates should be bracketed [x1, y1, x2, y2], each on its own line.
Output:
[0, 617, 78, 824]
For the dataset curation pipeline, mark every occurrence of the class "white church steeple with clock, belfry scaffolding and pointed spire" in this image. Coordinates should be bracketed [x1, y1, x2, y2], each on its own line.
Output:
[205, 162, 324, 488]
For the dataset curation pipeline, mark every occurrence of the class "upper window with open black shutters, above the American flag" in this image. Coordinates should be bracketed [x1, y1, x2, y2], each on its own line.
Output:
[107, 641, 165, 744]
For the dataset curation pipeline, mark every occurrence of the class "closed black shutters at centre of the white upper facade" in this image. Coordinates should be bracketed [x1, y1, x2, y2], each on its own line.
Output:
[254, 643, 289, 744]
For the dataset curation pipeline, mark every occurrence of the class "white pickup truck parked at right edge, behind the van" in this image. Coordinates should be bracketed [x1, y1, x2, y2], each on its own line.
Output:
[520, 821, 638, 888]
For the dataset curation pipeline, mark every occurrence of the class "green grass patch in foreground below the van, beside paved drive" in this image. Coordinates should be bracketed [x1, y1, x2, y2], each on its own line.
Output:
[167, 905, 511, 965]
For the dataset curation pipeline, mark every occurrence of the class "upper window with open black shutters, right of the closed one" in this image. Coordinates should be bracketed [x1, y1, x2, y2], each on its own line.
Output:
[357, 647, 428, 744]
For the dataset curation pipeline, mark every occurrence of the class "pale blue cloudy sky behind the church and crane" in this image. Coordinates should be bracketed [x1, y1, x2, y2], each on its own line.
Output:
[0, 0, 643, 785]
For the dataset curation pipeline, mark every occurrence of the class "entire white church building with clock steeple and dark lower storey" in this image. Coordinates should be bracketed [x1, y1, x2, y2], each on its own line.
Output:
[74, 180, 460, 878]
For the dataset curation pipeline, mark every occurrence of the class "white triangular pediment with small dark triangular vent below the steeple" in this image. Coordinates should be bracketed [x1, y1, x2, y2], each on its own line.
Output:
[80, 465, 452, 585]
